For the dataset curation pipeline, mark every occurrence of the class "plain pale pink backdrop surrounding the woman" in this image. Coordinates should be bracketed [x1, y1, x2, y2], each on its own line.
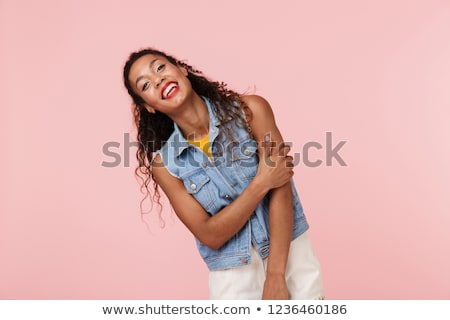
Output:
[0, 0, 450, 299]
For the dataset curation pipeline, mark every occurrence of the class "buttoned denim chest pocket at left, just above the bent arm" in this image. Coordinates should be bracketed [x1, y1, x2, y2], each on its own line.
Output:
[182, 169, 215, 213]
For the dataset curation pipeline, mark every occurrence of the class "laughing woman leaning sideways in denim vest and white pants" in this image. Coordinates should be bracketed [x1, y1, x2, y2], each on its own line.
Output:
[123, 49, 323, 299]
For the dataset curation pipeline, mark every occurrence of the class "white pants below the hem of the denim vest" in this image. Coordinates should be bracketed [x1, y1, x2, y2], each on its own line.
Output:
[209, 232, 324, 300]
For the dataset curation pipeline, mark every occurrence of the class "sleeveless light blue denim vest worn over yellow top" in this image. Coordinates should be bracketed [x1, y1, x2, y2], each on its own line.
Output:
[155, 98, 309, 270]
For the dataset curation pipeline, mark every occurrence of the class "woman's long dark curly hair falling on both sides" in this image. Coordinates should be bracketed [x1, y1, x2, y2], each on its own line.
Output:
[123, 48, 251, 220]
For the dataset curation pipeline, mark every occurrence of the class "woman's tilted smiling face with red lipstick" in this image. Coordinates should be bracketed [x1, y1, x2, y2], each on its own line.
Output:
[128, 54, 192, 114]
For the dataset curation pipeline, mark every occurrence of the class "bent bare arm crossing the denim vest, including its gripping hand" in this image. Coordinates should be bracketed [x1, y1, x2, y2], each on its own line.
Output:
[153, 131, 293, 249]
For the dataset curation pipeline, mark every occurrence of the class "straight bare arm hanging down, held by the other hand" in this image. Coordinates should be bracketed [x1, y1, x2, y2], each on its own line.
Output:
[244, 96, 293, 300]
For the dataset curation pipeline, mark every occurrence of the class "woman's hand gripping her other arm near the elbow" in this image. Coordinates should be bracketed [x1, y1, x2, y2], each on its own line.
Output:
[257, 134, 294, 190]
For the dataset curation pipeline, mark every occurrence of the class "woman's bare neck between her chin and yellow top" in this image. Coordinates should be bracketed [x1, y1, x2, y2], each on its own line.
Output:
[171, 93, 209, 140]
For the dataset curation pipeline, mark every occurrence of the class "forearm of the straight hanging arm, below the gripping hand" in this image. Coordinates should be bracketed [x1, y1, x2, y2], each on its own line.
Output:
[267, 183, 294, 276]
